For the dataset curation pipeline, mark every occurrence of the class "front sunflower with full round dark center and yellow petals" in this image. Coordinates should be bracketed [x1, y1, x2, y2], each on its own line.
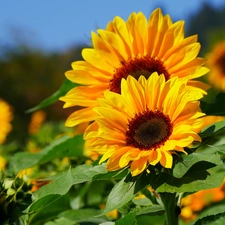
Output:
[84, 72, 205, 176]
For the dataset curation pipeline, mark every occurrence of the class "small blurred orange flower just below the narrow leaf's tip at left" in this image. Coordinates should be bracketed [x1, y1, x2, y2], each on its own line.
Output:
[28, 110, 46, 134]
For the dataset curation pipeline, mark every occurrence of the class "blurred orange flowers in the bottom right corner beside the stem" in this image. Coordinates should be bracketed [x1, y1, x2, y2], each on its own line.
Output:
[180, 182, 225, 221]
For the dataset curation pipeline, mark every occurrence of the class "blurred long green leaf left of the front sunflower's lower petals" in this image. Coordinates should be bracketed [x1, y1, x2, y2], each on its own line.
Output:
[10, 135, 83, 173]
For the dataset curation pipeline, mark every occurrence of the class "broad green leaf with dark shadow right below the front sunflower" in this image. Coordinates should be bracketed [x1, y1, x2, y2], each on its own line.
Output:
[148, 154, 225, 193]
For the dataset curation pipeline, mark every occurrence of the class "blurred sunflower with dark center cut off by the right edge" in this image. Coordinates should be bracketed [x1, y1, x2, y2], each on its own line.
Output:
[207, 41, 225, 92]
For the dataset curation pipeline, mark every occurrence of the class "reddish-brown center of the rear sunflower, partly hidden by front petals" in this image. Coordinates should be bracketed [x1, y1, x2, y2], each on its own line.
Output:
[109, 56, 170, 93]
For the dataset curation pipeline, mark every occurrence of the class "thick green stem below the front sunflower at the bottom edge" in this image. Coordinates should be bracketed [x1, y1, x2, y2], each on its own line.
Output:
[160, 192, 178, 225]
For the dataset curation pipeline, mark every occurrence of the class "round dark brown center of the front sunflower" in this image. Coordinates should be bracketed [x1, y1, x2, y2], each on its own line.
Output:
[126, 110, 173, 150]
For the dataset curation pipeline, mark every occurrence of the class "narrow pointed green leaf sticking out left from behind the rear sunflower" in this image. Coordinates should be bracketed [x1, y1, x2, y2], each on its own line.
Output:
[26, 79, 77, 113]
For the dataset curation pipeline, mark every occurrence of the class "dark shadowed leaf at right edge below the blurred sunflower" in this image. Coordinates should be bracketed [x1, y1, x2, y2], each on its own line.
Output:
[201, 93, 225, 116]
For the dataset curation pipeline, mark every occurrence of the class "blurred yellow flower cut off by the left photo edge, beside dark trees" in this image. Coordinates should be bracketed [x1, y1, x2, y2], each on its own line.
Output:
[0, 99, 13, 144]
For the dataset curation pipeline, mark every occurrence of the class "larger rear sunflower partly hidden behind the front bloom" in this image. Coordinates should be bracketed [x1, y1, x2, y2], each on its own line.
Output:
[60, 8, 208, 126]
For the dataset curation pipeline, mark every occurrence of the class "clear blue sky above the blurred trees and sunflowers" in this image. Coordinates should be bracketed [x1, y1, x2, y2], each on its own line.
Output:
[0, 0, 225, 51]
